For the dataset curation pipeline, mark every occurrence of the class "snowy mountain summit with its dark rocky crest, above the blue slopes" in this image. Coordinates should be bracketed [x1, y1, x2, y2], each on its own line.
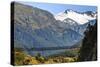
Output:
[55, 9, 96, 24]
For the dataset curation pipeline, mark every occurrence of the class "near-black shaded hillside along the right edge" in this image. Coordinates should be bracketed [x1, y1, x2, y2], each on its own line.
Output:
[78, 20, 97, 61]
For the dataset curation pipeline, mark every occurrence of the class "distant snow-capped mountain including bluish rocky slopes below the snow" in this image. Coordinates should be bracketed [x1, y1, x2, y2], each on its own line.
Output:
[55, 9, 97, 35]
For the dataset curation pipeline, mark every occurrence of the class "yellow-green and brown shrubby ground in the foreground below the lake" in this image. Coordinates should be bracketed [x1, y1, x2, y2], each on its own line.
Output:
[15, 49, 77, 65]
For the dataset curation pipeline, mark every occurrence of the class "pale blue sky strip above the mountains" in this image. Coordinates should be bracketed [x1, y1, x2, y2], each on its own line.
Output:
[20, 2, 97, 15]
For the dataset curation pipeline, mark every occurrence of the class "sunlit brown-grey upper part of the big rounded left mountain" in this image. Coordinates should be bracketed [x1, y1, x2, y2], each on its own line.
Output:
[14, 3, 55, 29]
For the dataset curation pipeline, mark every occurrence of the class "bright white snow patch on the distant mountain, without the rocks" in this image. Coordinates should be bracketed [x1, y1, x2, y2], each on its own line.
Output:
[55, 11, 96, 24]
